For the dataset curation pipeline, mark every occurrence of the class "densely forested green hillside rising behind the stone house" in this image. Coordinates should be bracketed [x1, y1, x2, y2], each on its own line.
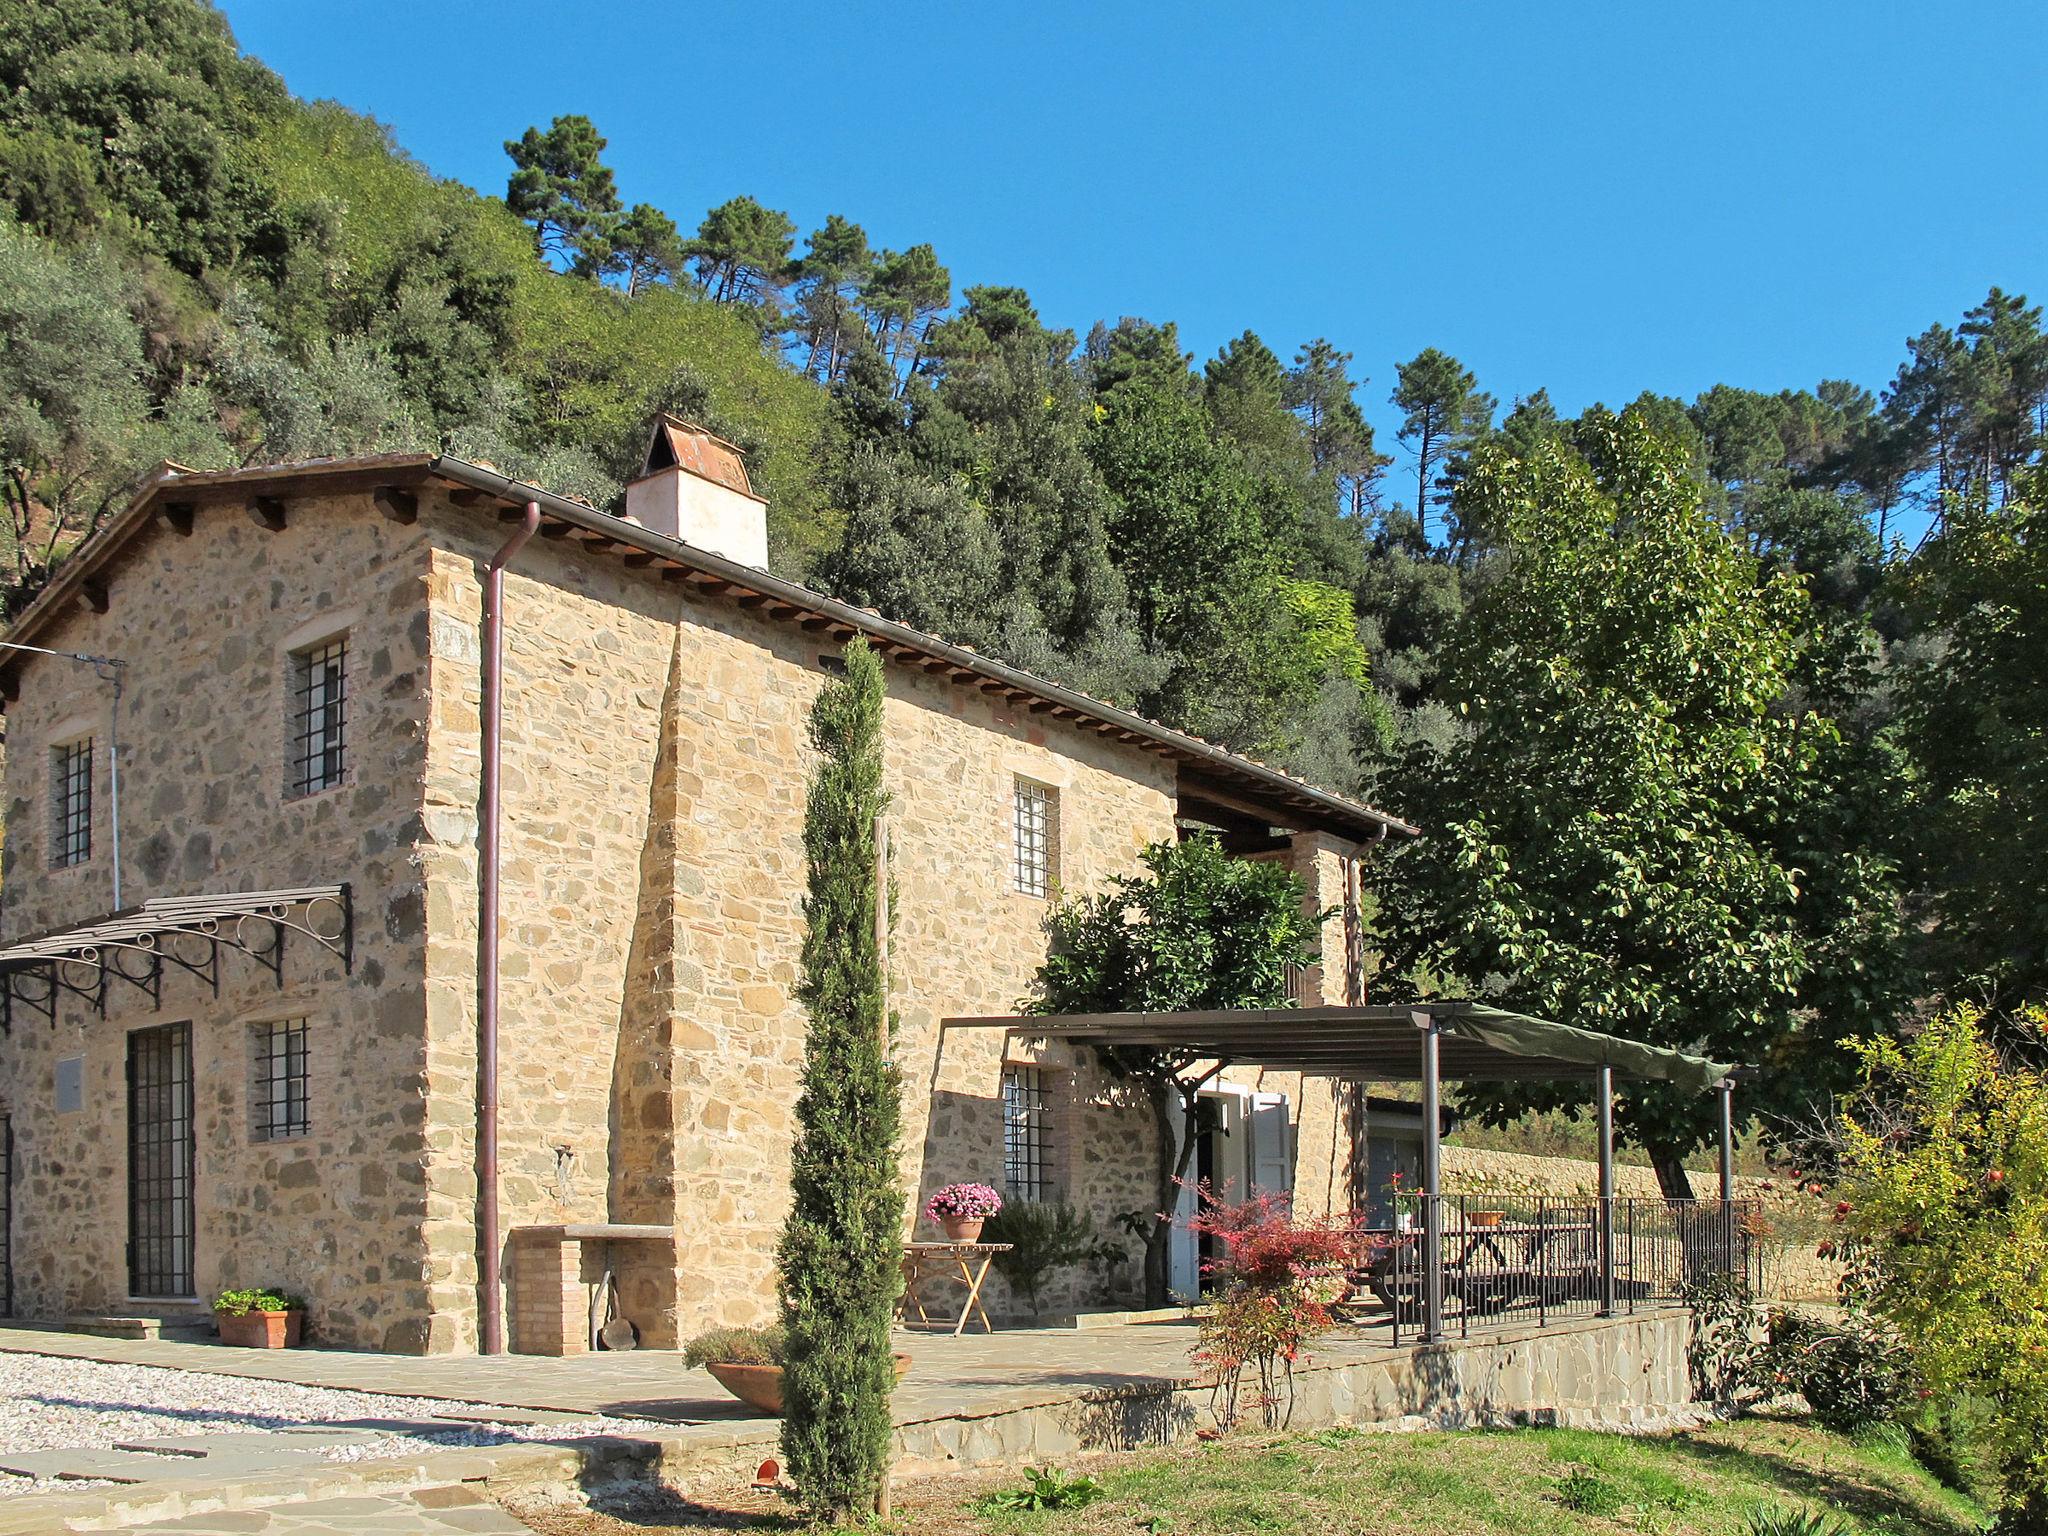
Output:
[0, 0, 2048, 1073]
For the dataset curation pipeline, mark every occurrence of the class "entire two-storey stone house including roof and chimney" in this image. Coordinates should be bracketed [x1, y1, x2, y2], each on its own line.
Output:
[0, 422, 1411, 1354]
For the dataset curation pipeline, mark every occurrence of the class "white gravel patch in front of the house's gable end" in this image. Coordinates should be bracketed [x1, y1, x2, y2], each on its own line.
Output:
[0, 1352, 674, 1493]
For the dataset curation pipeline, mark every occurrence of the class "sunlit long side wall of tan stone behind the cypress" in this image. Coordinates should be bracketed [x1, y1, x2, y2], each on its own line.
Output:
[424, 501, 1376, 1348]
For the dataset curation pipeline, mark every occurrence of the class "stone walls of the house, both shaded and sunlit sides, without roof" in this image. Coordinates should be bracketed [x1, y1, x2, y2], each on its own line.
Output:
[0, 487, 1384, 1352]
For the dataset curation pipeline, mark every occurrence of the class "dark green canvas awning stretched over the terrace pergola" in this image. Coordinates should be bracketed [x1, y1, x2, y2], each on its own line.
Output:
[944, 1001, 1735, 1094]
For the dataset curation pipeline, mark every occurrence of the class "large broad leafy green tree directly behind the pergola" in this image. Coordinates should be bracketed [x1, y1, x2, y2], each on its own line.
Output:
[1374, 412, 1898, 1198]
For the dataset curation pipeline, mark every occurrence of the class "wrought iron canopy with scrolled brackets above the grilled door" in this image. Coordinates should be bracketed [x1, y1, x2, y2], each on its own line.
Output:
[0, 883, 356, 1028]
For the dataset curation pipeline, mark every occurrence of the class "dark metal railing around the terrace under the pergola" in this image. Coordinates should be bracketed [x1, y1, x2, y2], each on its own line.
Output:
[1348, 1194, 1761, 1341]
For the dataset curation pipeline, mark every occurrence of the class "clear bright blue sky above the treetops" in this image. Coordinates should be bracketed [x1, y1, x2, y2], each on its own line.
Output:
[225, 0, 2048, 512]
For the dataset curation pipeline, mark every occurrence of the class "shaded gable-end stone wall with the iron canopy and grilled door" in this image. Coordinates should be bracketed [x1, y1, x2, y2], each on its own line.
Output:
[0, 498, 426, 1348]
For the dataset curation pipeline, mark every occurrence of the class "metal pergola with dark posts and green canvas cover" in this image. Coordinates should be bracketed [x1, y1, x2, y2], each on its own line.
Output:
[942, 1001, 1737, 1339]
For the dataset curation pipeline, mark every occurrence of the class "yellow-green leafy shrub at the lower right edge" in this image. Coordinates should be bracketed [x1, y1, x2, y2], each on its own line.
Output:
[1839, 1006, 2048, 1536]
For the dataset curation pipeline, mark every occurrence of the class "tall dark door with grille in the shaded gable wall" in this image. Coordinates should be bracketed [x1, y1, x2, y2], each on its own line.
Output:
[129, 1024, 193, 1296]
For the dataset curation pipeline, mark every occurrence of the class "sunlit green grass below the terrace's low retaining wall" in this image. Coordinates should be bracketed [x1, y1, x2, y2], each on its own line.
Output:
[503, 1417, 1985, 1536]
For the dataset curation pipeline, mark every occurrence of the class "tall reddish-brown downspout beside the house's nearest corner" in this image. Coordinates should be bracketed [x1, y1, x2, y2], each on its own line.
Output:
[477, 502, 541, 1354]
